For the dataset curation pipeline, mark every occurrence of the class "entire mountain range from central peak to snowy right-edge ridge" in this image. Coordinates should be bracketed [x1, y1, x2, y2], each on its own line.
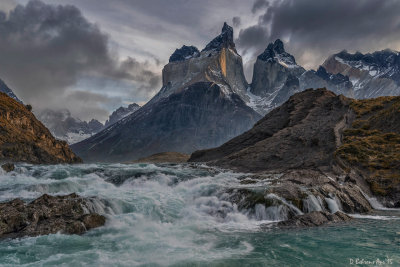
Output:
[72, 23, 400, 161]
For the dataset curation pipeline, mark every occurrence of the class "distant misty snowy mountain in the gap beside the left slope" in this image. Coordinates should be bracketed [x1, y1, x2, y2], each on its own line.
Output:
[37, 109, 104, 144]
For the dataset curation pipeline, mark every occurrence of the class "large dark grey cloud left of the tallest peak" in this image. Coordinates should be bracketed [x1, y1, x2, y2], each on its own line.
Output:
[0, 0, 160, 119]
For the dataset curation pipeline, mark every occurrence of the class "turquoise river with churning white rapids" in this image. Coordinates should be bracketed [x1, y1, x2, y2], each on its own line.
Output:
[0, 164, 400, 266]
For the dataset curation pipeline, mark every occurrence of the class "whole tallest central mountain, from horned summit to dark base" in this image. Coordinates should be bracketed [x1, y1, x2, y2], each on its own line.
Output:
[72, 23, 261, 161]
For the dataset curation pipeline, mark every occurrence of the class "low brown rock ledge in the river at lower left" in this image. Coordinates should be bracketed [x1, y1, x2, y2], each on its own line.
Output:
[0, 193, 106, 238]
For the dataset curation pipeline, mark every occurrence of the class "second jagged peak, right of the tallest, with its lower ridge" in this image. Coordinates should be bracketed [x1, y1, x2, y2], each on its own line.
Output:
[248, 39, 352, 115]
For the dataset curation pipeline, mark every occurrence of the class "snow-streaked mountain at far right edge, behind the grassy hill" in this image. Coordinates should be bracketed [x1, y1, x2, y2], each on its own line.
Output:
[323, 49, 400, 98]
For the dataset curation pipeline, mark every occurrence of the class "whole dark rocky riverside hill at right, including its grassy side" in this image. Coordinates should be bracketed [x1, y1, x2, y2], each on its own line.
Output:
[189, 89, 400, 208]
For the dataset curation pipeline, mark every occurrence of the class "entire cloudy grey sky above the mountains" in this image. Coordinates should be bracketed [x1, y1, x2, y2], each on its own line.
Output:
[0, 0, 400, 121]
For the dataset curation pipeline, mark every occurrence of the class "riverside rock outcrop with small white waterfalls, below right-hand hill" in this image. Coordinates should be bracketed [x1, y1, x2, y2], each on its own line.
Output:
[222, 170, 373, 226]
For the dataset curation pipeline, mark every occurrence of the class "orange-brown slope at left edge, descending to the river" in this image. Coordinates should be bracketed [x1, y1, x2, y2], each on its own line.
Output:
[0, 93, 81, 164]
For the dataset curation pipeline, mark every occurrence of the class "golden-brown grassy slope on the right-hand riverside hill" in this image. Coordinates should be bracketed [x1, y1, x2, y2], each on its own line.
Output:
[336, 97, 400, 196]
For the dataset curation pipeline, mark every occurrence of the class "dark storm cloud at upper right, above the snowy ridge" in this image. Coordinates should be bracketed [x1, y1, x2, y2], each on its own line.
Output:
[238, 0, 400, 68]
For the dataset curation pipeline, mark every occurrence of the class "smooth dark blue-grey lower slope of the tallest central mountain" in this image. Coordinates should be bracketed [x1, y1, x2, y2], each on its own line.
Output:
[72, 82, 260, 161]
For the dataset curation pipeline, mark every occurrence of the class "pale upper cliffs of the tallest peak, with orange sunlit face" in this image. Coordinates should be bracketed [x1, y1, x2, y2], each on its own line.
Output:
[150, 23, 248, 103]
